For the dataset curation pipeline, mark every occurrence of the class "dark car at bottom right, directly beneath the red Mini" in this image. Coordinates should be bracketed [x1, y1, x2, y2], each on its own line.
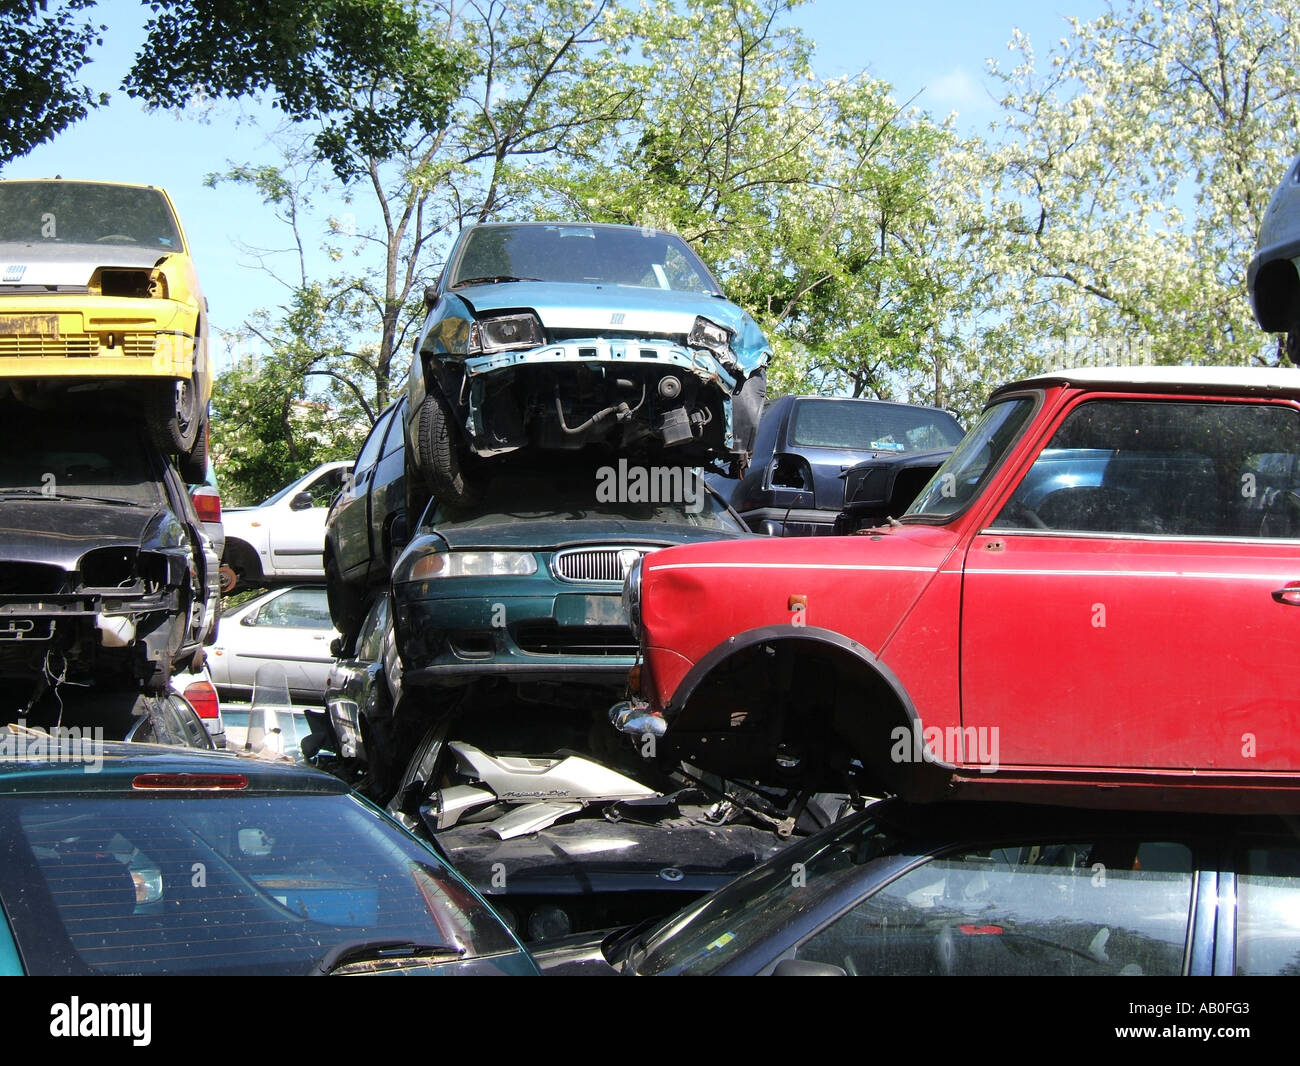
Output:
[537, 800, 1300, 976]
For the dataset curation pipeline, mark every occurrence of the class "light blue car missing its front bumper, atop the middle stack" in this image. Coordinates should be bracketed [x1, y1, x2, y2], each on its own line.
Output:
[407, 222, 771, 501]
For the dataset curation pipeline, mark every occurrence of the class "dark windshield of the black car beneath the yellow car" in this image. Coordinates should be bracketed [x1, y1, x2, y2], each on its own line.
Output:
[0, 412, 164, 507]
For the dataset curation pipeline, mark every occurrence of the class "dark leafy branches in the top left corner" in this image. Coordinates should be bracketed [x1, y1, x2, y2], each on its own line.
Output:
[0, 0, 108, 168]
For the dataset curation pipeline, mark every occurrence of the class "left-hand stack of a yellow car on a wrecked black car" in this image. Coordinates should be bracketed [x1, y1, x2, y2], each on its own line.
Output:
[0, 179, 220, 743]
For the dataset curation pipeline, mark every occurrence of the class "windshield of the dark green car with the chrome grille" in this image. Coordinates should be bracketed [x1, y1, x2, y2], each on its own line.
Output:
[433, 467, 745, 533]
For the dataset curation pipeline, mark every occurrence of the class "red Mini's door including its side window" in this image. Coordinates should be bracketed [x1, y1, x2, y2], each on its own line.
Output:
[961, 397, 1300, 771]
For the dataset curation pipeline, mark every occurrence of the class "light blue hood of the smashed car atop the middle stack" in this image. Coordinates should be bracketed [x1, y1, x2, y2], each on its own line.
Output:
[452, 281, 757, 338]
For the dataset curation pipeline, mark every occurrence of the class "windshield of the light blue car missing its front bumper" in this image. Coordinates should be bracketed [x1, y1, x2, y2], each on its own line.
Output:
[450, 225, 722, 296]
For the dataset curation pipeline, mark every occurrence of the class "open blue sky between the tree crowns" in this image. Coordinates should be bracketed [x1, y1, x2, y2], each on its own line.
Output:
[3, 0, 1104, 365]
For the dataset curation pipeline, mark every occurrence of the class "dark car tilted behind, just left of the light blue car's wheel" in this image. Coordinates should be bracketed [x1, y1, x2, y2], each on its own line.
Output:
[325, 397, 408, 645]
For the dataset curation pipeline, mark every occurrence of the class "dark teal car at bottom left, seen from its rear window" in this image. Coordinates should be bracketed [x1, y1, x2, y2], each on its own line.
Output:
[0, 733, 537, 976]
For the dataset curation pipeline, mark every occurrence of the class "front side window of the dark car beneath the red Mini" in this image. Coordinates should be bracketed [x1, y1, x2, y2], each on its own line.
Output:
[797, 840, 1192, 976]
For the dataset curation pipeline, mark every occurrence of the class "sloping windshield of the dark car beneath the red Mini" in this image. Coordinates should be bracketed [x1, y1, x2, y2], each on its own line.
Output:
[619, 815, 894, 975]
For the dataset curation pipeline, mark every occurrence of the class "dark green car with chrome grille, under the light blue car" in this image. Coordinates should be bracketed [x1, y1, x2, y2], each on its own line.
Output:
[393, 460, 750, 702]
